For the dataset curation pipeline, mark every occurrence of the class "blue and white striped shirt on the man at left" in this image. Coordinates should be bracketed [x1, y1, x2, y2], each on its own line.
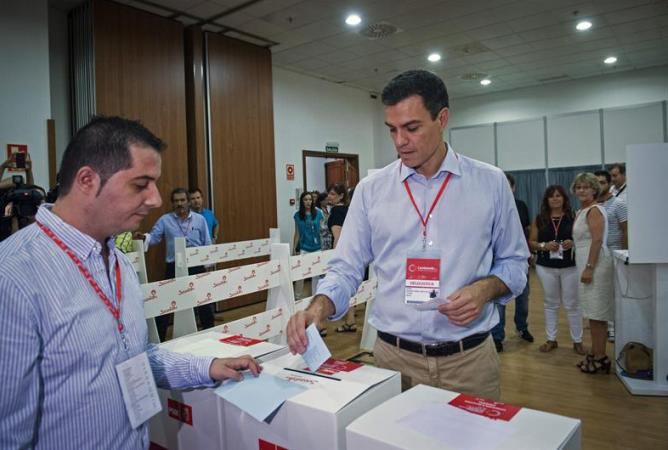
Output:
[0, 205, 213, 450]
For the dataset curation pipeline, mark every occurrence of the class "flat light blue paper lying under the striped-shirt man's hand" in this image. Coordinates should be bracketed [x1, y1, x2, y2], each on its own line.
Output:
[216, 372, 306, 422]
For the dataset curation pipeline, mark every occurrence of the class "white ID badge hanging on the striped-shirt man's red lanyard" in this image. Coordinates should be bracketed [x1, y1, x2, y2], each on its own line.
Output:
[116, 352, 162, 429]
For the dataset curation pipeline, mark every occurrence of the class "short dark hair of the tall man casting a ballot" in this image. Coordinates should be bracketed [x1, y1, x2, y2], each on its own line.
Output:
[381, 70, 450, 120]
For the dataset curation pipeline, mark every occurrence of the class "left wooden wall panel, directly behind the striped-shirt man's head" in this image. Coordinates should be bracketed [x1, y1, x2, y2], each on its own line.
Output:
[93, 0, 188, 280]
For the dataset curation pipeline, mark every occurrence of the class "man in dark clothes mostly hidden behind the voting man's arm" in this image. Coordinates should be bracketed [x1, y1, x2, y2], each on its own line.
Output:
[492, 172, 534, 353]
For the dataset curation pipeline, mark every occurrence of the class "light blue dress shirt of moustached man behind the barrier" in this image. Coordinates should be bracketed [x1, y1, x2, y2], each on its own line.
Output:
[146, 211, 211, 262]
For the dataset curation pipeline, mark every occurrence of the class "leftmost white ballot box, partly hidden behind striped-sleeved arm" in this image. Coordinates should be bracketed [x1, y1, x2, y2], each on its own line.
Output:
[149, 331, 285, 450]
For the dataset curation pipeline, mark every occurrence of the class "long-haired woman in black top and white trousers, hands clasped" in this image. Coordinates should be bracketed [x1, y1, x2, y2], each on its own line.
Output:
[529, 185, 585, 355]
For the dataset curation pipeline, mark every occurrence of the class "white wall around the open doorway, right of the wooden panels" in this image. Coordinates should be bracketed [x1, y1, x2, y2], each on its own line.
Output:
[273, 67, 378, 242]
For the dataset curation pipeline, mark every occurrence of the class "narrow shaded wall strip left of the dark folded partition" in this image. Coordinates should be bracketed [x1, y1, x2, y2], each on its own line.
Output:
[49, 7, 71, 170]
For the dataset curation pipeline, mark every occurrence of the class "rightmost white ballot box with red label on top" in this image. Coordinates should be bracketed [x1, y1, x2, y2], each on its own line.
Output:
[346, 385, 580, 450]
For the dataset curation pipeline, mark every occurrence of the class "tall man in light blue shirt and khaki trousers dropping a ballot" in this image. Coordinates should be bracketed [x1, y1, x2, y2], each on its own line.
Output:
[287, 71, 529, 399]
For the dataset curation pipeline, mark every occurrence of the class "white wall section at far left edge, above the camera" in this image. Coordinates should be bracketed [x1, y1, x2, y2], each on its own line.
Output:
[0, 0, 51, 186]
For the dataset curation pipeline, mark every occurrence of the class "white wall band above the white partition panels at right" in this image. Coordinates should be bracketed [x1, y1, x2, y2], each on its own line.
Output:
[445, 66, 668, 127]
